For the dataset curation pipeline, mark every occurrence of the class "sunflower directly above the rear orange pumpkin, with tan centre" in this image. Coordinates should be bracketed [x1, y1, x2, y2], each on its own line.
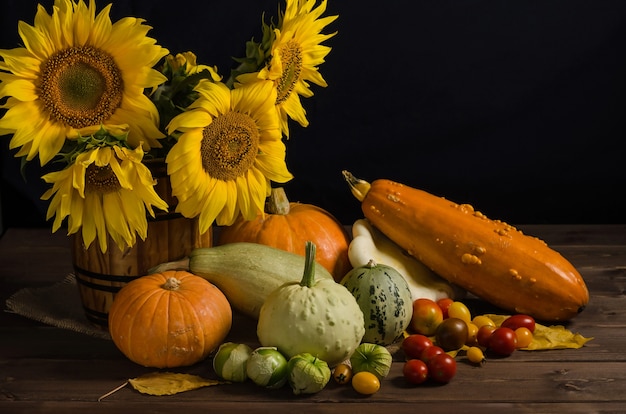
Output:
[166, 81, 293, 233]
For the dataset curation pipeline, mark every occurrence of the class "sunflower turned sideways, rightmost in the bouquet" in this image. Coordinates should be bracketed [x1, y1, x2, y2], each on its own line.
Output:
[237, 0, 338, 137]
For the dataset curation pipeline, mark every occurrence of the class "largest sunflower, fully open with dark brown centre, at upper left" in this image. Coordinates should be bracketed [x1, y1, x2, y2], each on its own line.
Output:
[0, 0, 168, 165]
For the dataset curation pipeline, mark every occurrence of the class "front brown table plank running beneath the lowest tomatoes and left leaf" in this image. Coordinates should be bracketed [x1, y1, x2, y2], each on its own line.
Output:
[0, 359, 626, 404]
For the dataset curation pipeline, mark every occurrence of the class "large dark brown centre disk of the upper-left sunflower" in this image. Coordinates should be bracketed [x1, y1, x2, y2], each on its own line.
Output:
[40, 46, 124, 128]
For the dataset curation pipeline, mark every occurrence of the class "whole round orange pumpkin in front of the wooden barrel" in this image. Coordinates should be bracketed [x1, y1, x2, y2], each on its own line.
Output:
[109, 270, 233, 368]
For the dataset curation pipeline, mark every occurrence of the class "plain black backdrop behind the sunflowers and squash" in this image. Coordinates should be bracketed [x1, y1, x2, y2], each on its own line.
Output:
[0, 0, 626, 230]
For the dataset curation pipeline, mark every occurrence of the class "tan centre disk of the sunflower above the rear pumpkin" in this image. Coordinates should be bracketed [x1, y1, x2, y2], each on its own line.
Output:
[200, 111, 259, 181]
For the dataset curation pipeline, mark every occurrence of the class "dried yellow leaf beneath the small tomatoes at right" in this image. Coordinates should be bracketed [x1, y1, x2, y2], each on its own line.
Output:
[486, 314, 593, 351]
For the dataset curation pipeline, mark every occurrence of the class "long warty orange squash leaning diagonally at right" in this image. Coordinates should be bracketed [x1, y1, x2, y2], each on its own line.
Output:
[343, 171, 589, 321]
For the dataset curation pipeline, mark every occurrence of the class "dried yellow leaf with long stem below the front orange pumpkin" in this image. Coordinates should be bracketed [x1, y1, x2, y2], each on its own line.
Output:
[128, 372, 221, 395]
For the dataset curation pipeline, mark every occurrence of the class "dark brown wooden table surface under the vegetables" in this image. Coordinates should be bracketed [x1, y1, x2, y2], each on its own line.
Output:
[0, 225, 626, 414]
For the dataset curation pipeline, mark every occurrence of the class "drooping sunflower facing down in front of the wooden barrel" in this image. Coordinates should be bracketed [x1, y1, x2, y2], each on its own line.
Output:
[41, 145, 167, 253]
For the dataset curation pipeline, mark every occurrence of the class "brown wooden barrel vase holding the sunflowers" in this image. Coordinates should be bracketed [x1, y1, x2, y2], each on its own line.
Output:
[71, 162, 213, 329]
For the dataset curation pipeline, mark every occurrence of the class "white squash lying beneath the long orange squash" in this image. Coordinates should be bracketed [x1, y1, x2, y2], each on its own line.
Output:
[348, 219, 464, 301]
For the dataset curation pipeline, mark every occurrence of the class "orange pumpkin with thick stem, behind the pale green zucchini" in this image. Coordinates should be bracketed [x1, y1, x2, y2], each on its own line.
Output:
[217, 187, 352, 282]
